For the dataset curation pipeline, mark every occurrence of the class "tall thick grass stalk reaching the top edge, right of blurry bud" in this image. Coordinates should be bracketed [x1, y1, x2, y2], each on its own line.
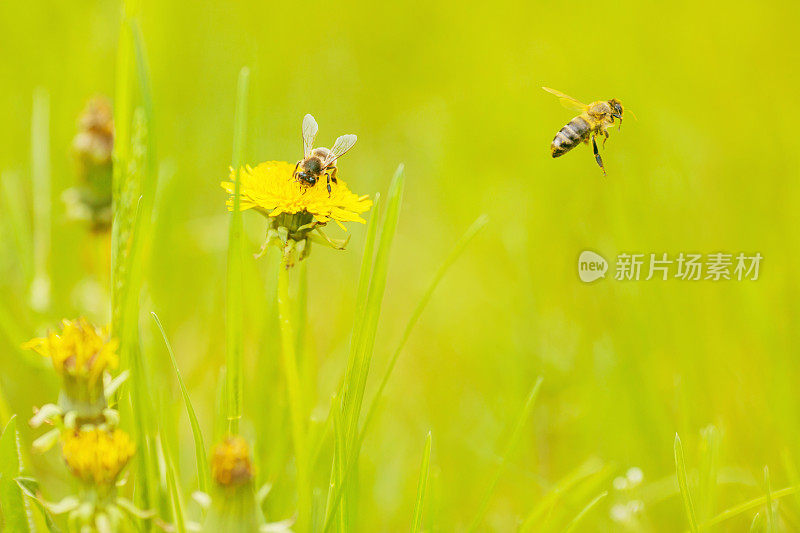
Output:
[112, 12, 162, 529]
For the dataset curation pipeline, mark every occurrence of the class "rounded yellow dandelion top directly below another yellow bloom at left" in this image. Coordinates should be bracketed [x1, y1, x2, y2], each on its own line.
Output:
[61, 429, 136, 487]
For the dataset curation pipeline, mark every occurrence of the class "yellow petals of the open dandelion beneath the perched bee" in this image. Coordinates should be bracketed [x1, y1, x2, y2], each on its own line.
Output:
[220, 161, 372, 228]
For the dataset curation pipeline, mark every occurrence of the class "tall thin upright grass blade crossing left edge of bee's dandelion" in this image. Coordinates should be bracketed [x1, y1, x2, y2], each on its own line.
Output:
[225, 67, 250, 434]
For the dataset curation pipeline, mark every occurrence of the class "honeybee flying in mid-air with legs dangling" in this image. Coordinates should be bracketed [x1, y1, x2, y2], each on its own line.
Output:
[542, 87, 622, 175]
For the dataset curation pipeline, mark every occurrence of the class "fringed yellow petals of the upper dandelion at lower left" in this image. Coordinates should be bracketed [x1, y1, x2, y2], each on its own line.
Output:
[23, 318, 119, 385]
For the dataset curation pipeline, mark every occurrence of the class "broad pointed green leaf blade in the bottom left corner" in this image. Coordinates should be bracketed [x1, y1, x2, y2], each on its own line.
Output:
[0, 416, 32, 533]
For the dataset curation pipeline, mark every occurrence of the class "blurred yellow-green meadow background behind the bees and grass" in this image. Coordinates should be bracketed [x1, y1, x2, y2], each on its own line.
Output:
[0, 0, 800, 531]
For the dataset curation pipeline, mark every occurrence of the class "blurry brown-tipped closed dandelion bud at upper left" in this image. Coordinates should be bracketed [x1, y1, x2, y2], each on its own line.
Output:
[63, 97, 114, 231]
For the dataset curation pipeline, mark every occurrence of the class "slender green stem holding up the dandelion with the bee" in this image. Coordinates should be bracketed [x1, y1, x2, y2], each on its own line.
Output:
[278, 256, 311, 532]
